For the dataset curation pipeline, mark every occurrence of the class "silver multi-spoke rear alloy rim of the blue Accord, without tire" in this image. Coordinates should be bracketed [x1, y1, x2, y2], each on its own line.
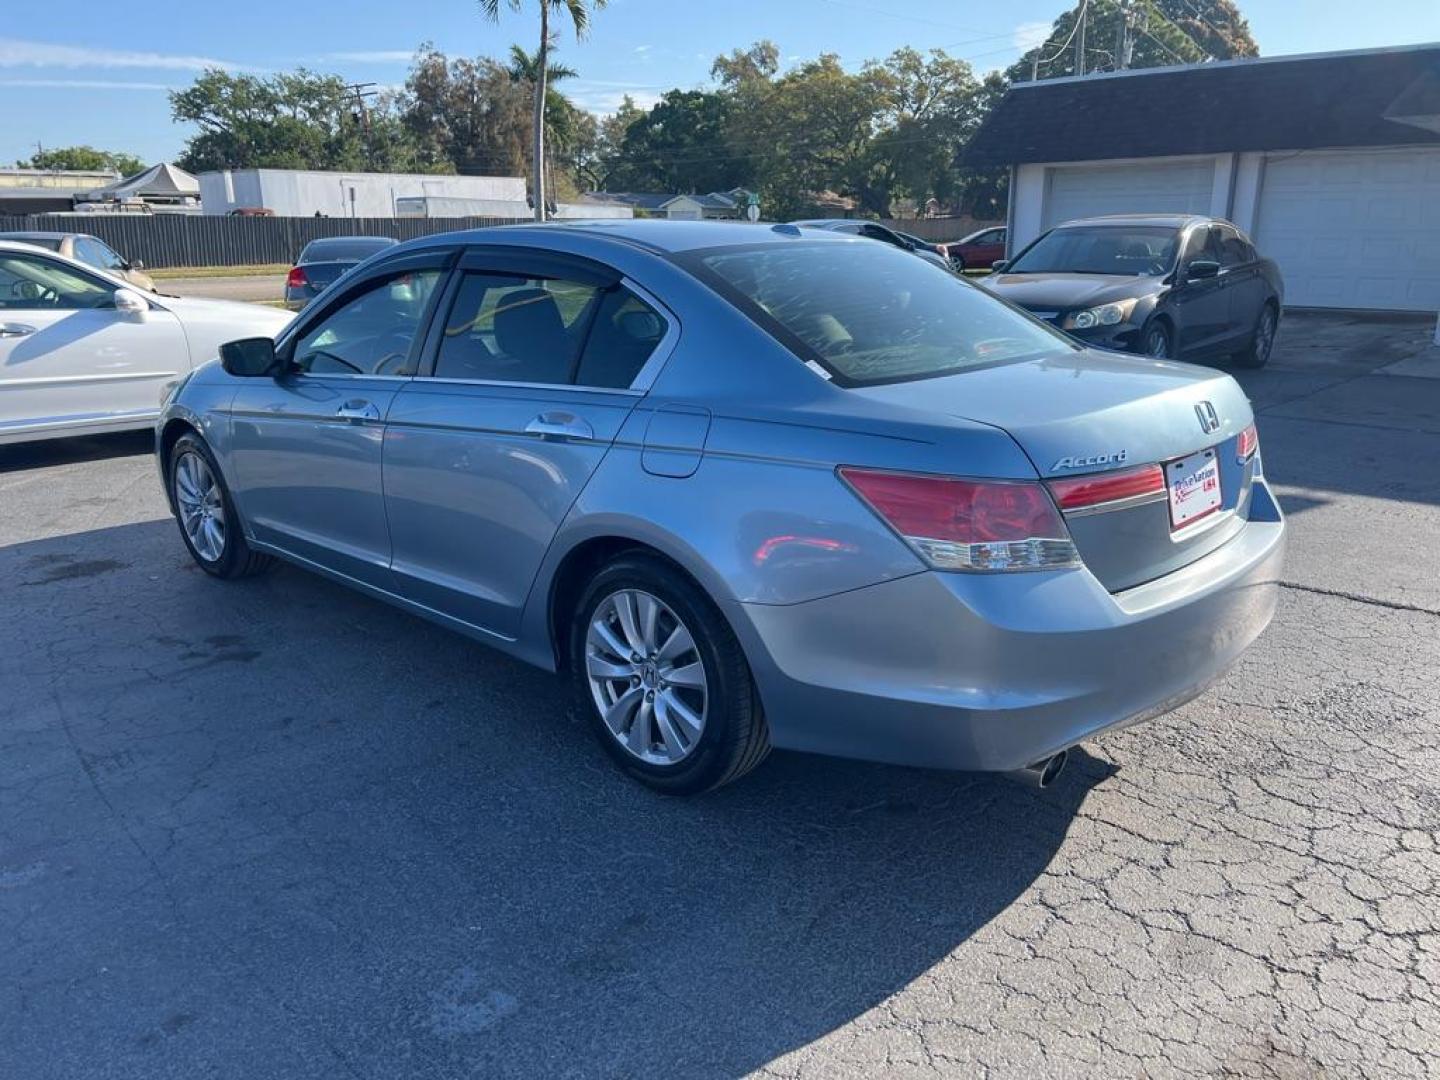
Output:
[585, 589, 710, 765]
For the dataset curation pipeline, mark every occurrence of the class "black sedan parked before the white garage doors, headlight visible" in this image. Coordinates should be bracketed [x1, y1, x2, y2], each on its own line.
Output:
[982, 215, 1284, 367]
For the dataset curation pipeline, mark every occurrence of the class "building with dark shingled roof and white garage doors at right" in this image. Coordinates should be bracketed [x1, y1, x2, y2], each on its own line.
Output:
[960, 45, 1440, 311]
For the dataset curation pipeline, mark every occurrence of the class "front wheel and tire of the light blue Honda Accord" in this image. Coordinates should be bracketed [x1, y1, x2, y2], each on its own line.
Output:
[166, 433, 274, 580]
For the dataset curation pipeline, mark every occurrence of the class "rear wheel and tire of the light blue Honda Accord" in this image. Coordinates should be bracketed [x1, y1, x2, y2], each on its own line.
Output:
[570, 552, 770, 795]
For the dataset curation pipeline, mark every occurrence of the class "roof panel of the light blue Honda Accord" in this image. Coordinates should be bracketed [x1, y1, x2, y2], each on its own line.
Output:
[388, 217, 852, 253]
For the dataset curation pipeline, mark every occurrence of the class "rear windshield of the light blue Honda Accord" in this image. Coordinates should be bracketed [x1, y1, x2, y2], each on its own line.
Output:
[685, 240, 1077, 386]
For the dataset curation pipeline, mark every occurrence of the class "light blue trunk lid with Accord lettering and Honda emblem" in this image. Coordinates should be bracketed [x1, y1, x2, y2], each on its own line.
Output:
[852, 351, 1254, 592]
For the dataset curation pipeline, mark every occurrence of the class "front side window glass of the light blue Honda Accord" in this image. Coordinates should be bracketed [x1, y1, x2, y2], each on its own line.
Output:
[294, 269, 441, 376]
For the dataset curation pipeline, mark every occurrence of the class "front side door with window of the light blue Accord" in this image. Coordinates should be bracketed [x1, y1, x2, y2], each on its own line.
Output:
[229, 252, 445, 590]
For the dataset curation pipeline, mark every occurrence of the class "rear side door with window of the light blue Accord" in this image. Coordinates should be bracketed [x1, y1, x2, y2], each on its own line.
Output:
[384, 249, 678, 636]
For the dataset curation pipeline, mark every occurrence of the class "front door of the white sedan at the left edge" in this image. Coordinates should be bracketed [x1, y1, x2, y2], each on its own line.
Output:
[0, 249, 190, 439]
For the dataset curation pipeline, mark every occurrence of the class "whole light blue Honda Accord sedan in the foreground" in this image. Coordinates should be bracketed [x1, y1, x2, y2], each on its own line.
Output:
[157, 222, 1284, 793]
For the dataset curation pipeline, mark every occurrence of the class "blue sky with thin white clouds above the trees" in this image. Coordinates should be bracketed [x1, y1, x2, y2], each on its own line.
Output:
[0, 0, 1440, 164]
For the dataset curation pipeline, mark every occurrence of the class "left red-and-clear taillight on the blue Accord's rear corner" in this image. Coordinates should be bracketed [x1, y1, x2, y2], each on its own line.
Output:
[840, 468, 1080, 570]
